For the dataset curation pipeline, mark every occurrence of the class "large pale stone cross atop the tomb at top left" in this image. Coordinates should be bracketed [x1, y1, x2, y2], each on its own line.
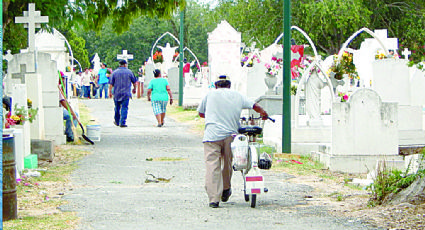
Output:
[15, 3, 49, 52]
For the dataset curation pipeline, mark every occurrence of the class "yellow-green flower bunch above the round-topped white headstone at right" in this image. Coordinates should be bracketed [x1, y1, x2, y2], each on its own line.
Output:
[328, 52, 359, 80]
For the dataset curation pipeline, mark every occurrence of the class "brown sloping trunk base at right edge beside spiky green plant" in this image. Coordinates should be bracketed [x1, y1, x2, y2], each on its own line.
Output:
[385, 175, 425, 205]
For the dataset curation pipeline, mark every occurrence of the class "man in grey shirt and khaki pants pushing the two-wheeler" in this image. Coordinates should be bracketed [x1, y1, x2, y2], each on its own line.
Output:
[197, 75, 268, 208]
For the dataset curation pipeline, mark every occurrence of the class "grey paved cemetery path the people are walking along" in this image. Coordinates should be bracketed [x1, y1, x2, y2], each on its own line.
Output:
[61, 99, 374, 230]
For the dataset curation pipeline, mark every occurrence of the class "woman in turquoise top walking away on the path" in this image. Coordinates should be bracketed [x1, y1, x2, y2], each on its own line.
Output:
[147, 69, 173, 127]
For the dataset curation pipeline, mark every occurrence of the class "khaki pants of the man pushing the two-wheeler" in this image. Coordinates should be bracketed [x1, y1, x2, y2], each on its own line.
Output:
[204, 137, 233, 203]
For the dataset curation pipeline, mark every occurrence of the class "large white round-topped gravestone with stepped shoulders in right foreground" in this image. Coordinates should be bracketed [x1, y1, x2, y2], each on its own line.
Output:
[327, 89, 401, 173]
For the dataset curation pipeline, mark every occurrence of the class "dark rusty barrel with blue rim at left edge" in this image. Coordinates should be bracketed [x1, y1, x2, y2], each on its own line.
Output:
[3, 135, 18, 221]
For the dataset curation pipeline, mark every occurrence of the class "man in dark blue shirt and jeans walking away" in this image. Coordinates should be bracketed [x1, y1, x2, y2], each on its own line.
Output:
[109, 60, 137, 128]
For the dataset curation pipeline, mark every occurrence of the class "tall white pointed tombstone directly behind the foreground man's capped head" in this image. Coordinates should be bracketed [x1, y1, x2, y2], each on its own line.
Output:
[208, 21, 241, 86]
